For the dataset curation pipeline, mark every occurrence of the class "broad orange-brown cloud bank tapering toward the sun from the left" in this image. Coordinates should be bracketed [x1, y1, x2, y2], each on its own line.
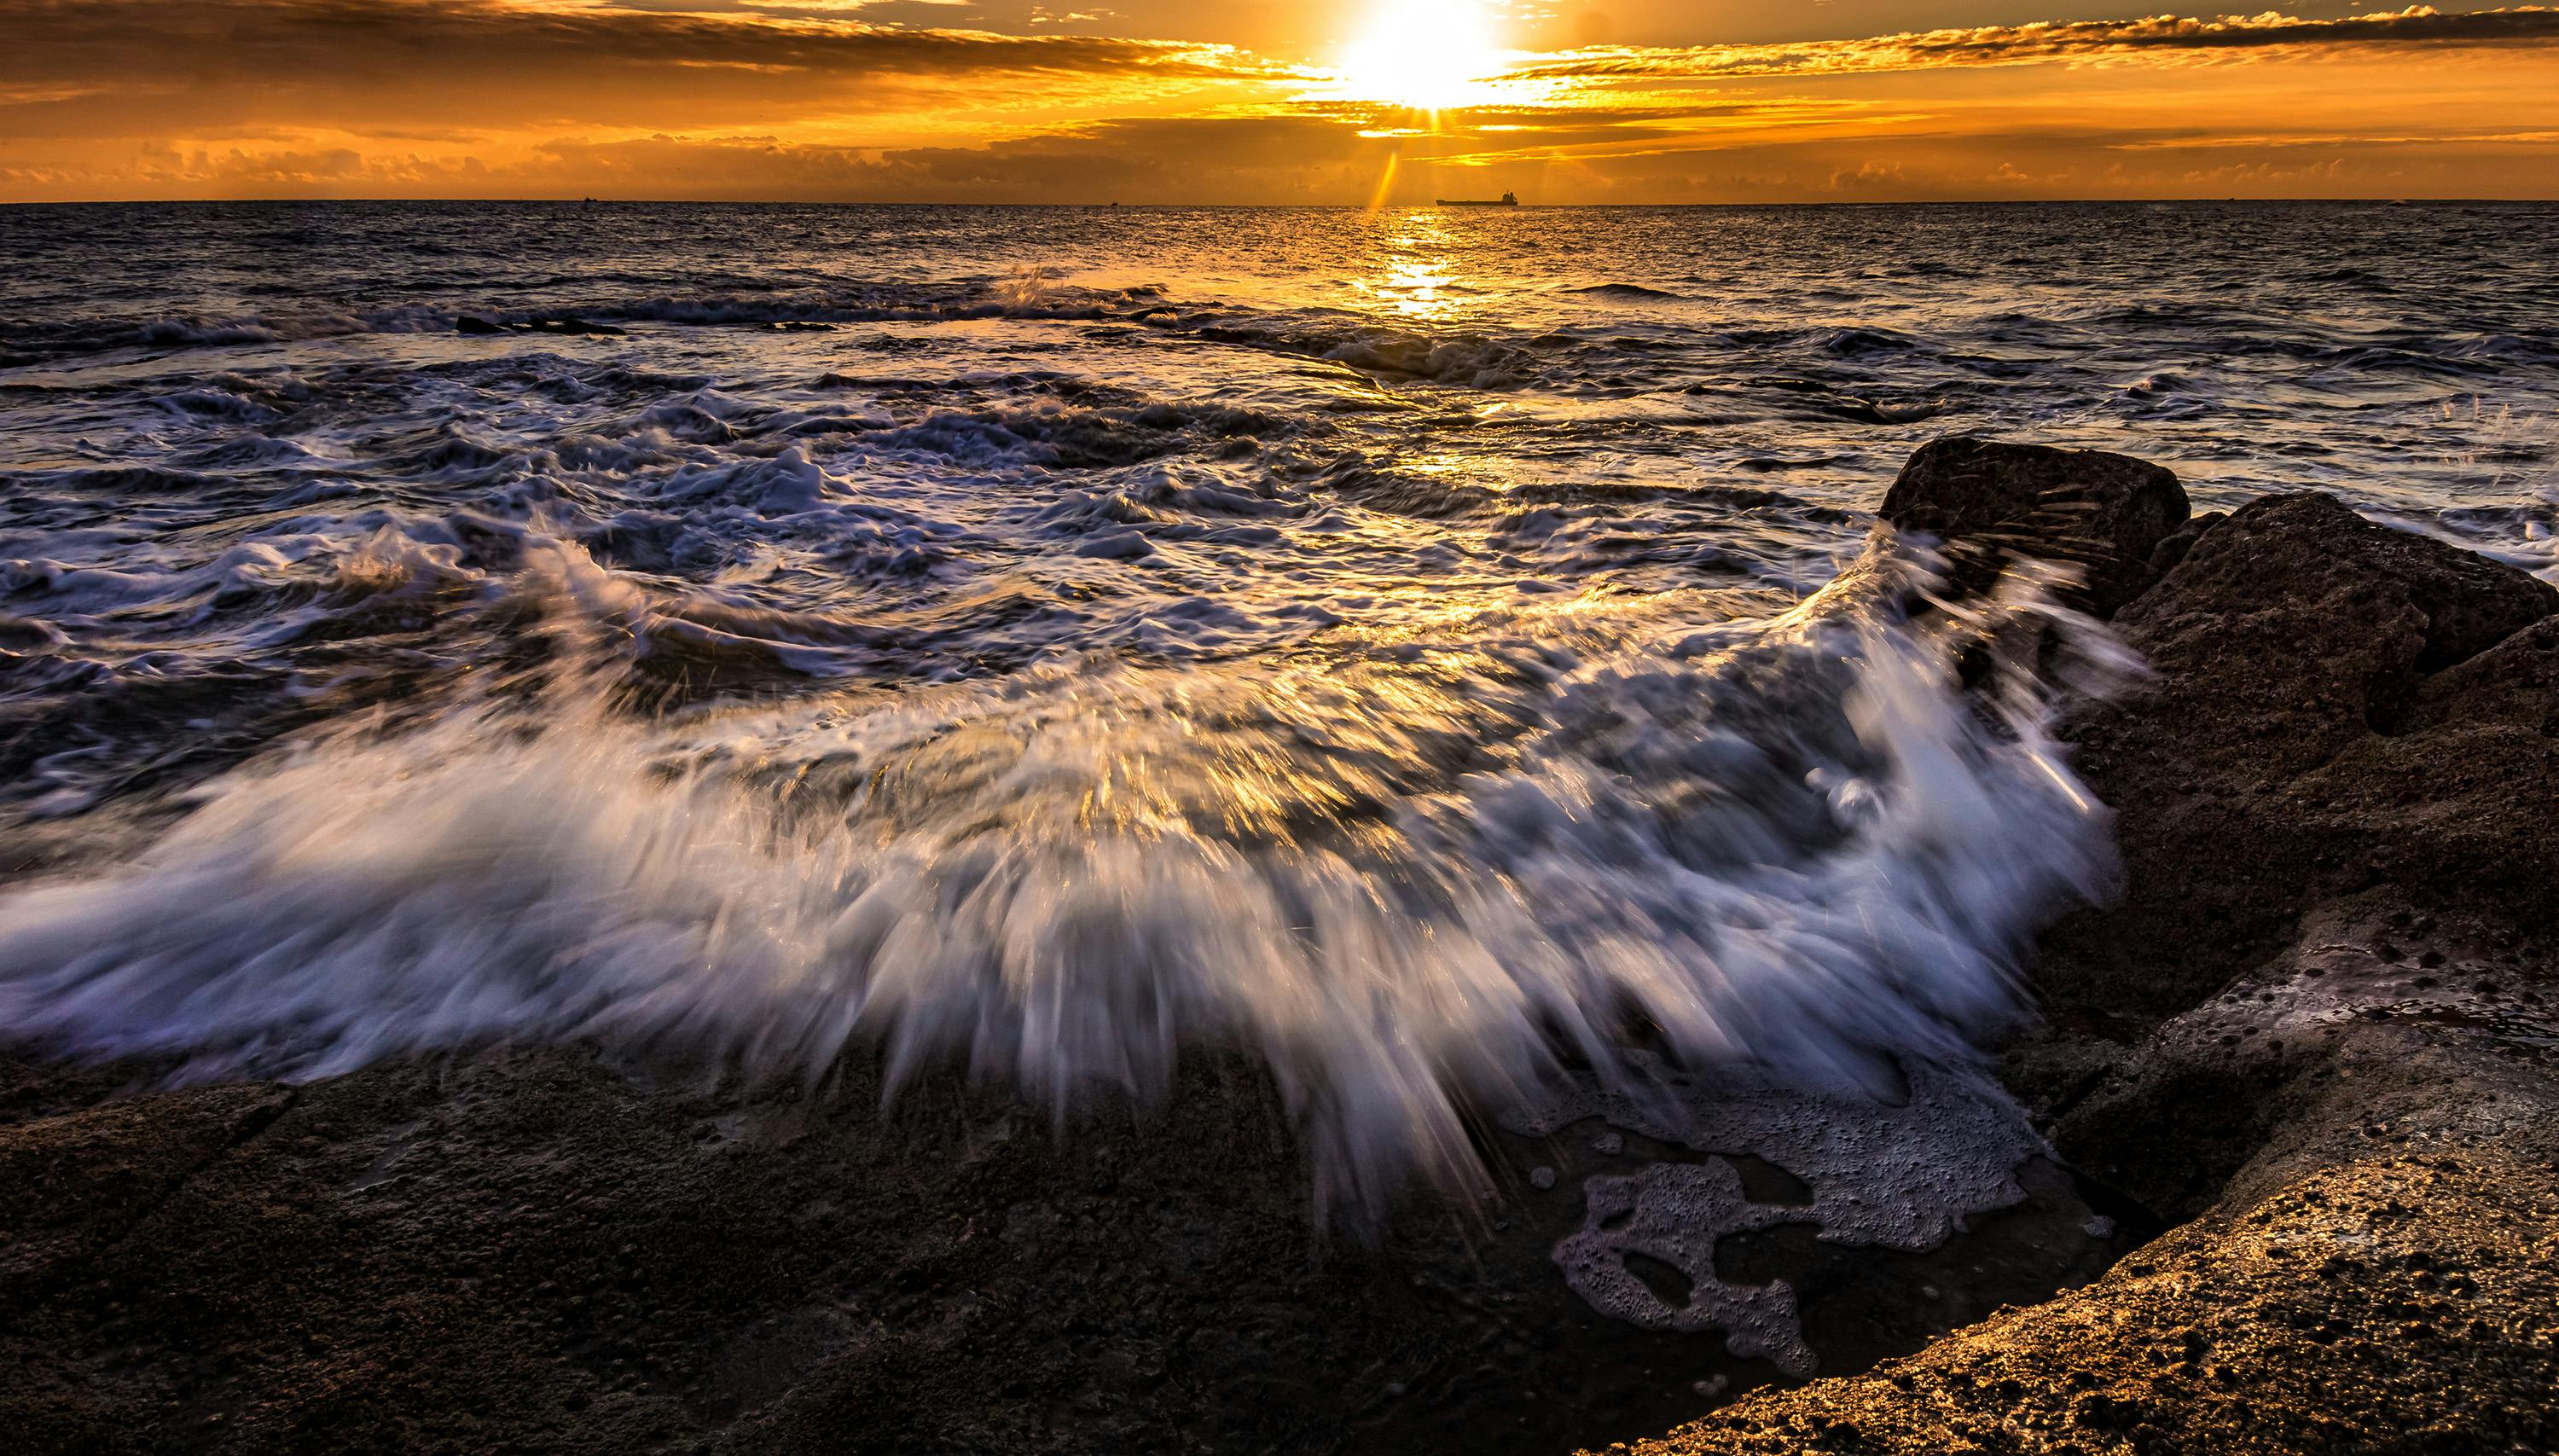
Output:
[0, 0, 1274, 138]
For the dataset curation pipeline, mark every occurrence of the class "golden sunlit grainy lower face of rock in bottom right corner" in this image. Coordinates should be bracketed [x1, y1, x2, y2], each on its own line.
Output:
[1635, 1126, 2559, 1456]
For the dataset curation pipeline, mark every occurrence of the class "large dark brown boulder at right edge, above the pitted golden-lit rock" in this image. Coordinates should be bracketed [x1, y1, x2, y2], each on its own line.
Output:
[2040, 494, 2559, 1021]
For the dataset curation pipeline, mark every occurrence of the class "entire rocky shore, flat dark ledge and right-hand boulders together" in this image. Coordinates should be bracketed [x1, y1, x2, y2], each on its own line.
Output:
[0, 440, 2559, 1453]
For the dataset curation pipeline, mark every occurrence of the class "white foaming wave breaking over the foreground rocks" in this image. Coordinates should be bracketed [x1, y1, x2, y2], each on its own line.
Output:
[0, 527, 2109, 1208]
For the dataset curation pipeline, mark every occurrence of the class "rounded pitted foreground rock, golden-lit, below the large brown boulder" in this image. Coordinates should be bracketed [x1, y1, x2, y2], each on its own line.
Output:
[1635, 914, 2559, 1456]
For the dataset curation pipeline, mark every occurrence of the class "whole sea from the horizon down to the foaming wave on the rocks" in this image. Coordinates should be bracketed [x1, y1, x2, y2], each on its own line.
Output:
[0, 205, 2559, 1190]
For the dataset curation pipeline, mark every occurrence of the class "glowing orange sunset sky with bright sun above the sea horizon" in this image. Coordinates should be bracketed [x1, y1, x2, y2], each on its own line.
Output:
[0, 0, 2559, 202]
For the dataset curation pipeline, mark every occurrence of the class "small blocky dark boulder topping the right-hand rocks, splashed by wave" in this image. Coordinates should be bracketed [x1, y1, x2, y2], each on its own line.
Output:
[1878, 438, 2188, 617]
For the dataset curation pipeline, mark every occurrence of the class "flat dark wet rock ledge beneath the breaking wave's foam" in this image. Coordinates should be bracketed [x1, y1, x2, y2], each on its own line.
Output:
[0, 1052, 2134, 1453]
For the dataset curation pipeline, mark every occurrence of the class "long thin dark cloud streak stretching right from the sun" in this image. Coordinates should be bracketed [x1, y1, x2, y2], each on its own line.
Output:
[1517, 5, 2559, 79]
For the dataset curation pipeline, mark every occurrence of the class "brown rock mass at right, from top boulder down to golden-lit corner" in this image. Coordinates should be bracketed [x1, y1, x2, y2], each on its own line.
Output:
[1610, 440, 2559, 1456]
